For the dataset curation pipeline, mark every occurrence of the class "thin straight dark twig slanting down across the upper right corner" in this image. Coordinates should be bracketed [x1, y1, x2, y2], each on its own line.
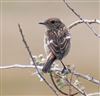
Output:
[63, 0, 100, 38]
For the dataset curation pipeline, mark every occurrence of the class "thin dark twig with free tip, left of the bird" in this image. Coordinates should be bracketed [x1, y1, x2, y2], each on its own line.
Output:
[18, 24, 58, 96]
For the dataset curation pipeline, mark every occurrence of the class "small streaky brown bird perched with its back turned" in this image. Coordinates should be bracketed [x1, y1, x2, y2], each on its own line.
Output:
[39, 17, 71, 73]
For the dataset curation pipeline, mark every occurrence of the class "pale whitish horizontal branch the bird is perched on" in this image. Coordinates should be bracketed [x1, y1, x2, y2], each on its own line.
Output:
[0, 64, 100, 86]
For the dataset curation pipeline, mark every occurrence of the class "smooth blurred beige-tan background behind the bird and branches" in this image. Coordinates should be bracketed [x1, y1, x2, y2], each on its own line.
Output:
[0, 0, 100, 96]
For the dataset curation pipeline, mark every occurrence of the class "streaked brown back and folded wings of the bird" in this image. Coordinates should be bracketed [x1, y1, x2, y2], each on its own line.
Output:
[48, 30, 70, 59]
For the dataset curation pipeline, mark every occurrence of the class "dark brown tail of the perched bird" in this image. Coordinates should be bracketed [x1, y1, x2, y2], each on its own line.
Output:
[42, 54, 56, 73]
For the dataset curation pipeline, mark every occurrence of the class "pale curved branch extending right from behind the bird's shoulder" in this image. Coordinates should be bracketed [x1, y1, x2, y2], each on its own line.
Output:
[67, 19, 100, 30]
